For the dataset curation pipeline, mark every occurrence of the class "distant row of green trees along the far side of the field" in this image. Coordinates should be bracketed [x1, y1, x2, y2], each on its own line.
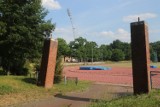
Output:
[59, 37, 160, 62]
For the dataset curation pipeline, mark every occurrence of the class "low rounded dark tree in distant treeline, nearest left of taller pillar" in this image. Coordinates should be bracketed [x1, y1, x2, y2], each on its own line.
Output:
[111, 49, 124, 61]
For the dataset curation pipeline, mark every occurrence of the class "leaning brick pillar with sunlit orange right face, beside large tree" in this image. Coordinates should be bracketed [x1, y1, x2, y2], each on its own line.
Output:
[38, 38, 58, 88]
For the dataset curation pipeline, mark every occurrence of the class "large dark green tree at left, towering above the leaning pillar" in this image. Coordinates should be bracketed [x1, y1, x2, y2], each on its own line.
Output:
[0, 0, 54, 75]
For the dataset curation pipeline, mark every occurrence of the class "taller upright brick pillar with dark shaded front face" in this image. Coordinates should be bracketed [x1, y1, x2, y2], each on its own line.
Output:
[131, 21, 151, 94]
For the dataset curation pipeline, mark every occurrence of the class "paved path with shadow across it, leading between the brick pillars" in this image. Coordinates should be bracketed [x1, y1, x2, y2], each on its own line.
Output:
[16, 84, 133, 107]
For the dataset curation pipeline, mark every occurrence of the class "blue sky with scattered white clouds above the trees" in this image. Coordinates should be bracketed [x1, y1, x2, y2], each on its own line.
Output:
[42, 0, 160, 45]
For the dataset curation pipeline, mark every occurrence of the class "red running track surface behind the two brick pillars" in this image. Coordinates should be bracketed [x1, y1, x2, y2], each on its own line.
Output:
[63, 66, 160, 86]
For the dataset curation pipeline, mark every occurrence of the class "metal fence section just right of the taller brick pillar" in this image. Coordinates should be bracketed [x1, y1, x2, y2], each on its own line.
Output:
[150, 71, 160, 89]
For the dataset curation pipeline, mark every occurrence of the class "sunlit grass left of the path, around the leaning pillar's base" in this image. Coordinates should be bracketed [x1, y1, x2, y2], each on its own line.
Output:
[0, 76, 91, 107]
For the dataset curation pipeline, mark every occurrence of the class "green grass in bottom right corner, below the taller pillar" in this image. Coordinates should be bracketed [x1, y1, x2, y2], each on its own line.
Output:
[89, 90, 160, 107]
